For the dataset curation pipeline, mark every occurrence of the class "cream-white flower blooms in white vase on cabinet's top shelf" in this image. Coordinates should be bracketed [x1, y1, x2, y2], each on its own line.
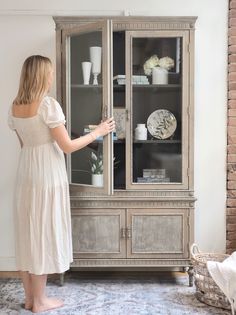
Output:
[143, 55, 175, 75]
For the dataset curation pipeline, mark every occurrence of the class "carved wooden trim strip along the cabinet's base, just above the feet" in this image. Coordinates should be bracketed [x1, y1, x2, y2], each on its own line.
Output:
[71, 258, 191, 267]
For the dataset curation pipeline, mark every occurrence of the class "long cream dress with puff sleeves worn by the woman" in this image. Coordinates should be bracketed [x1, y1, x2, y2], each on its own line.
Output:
[8, 96, 72, 275]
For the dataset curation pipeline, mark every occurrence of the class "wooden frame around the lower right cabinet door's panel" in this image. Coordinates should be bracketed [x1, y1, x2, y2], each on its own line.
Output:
[126, 208, 191, 259]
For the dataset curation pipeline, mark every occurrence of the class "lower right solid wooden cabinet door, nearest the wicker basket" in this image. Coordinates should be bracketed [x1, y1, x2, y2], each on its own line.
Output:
[127, 209, 189, 259]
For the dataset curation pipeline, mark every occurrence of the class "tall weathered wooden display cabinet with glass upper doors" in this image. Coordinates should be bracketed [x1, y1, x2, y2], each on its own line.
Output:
[54, 16, 196, 285]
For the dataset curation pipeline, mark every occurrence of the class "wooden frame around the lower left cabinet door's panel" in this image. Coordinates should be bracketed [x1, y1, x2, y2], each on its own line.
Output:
[72, 208, 127, 259]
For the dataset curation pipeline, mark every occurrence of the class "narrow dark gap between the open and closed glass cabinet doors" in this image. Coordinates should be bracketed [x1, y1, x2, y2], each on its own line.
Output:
[113, 31, 126, 189]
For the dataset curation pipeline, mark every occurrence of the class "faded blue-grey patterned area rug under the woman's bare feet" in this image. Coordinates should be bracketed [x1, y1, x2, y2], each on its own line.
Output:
[0, 276, 230, 315]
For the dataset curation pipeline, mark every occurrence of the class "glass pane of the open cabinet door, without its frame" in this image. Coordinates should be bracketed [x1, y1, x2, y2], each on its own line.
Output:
[70, 31, 103, 187]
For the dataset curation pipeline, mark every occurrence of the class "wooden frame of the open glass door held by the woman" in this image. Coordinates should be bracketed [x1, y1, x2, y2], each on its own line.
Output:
[61, 20, 113, 195]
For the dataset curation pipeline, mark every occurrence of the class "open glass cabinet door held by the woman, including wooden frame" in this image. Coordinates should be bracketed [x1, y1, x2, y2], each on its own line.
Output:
[62, 21, 111, 193]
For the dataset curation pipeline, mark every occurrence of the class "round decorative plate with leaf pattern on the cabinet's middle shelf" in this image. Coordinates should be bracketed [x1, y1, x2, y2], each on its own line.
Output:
[147, 109, 177, 139]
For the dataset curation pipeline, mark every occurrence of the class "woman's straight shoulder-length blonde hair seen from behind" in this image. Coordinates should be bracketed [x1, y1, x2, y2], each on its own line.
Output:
[13, 55, 52, 105]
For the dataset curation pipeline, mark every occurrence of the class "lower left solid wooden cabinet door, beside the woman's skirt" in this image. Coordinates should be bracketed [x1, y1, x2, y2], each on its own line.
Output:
[72, 209, 126, 258]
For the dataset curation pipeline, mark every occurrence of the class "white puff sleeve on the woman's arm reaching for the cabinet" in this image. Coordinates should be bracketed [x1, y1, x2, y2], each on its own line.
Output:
[41, 97, 66, 128]
